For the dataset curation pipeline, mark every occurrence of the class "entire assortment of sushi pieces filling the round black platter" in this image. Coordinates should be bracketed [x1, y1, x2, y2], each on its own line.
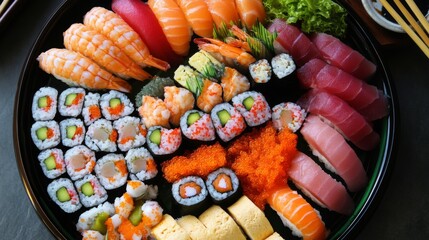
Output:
[26, 0, 389, 239]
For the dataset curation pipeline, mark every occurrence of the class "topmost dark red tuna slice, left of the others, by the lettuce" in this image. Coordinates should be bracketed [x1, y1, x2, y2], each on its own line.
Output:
[268, 19, 321, 66]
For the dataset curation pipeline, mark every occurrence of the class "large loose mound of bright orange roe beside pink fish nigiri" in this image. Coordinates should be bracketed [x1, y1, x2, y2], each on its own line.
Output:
[227, 124, 297, 209]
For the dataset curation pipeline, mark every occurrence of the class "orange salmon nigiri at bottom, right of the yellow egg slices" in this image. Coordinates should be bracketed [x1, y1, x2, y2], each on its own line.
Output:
[268, 186, 327, 240]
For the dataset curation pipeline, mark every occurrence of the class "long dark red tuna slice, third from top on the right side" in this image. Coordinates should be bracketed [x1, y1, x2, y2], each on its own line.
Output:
[297, 59, 389, 121]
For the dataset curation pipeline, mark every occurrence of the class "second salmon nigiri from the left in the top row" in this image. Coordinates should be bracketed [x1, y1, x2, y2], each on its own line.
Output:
[176, 0, 213, 37]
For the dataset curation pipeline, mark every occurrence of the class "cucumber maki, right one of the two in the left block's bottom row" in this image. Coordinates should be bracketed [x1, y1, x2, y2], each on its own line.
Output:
[75, 174, 107, 207]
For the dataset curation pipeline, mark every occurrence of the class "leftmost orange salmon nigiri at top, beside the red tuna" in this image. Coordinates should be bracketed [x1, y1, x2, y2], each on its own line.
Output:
[147, 0, 192, 56]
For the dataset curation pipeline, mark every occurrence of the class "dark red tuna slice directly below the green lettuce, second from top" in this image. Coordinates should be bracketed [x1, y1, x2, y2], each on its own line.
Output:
[312, 33, 377, 79]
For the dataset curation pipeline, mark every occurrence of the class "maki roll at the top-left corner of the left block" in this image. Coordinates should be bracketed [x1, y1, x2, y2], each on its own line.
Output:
[31, 87, 58, 121]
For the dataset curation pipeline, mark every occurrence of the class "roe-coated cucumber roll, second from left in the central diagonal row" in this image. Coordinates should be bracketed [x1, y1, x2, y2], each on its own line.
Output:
[180, 110, 216, 141]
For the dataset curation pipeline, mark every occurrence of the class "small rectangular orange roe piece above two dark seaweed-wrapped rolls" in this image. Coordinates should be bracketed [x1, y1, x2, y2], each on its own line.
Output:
[162, 143, 227, 182]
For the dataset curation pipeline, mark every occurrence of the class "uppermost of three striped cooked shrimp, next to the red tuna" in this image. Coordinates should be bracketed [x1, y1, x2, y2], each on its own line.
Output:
[83, 7, 170, 71]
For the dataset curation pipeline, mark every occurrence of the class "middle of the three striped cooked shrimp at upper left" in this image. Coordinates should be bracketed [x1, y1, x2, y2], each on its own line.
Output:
[64, 23, 151, 81]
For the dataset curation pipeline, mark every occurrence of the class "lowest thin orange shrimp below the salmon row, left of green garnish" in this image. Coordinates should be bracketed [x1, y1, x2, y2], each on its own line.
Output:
[194, 38, 256, 68]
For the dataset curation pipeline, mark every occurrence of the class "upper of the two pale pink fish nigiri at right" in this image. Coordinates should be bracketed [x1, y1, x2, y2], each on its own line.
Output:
[301, 115, 368, 192]
